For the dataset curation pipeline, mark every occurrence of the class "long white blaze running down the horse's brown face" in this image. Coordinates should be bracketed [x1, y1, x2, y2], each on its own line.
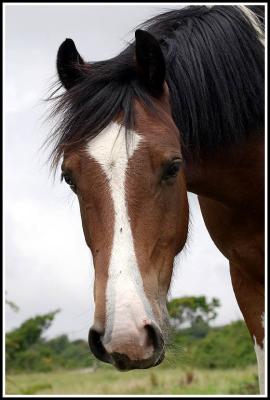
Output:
[87, 123, 153, 358]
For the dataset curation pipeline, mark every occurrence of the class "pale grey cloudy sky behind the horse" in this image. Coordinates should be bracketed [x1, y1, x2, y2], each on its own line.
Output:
[4, 4, 242, 339]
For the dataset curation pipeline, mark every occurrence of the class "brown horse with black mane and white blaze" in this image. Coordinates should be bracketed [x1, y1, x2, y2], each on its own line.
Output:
[48, 5, 264, 393]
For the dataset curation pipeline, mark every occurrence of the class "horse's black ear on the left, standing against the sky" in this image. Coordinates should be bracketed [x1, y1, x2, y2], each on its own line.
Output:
[56, 39, 84, 89]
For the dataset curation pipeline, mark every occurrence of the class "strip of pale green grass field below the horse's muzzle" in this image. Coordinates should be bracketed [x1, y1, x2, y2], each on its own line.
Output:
[6, 366, 259, 395]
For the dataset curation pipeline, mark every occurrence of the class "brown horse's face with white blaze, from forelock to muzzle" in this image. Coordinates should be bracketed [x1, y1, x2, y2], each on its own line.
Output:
[62, 97, 188, 369]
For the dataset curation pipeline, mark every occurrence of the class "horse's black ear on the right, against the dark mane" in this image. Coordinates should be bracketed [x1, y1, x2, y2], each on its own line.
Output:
[135, 29, 166, 95]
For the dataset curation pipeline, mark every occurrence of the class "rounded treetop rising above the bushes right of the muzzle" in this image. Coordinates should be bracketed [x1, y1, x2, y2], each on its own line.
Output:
[167, 296, 220, 329]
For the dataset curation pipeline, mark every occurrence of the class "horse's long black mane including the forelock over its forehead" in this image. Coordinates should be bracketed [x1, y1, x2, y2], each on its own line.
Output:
[46, 5, 264, 165]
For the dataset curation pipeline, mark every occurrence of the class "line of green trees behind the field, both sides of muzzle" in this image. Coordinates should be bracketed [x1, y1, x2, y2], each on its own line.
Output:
[6, 296, 256, 372]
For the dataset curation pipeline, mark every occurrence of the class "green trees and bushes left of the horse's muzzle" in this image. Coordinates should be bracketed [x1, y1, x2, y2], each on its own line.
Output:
[6, 310, 96, 373]
